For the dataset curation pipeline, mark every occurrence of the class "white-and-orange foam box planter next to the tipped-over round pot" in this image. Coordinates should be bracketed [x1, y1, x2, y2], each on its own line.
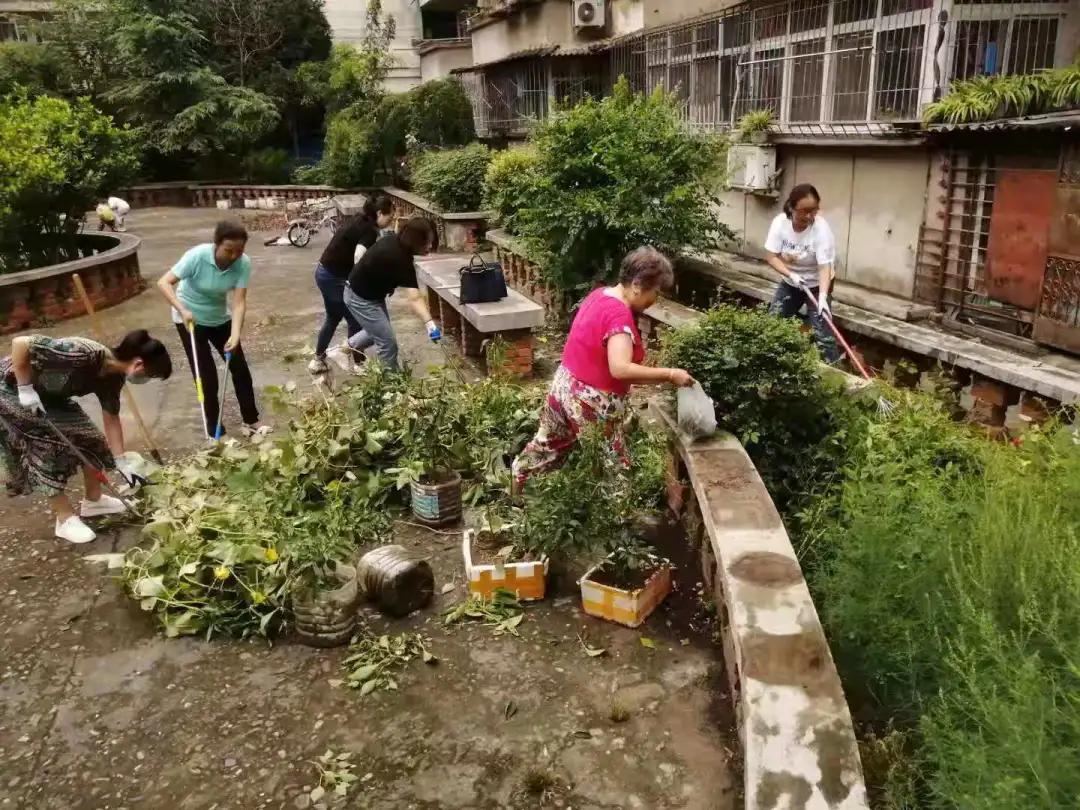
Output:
[461, 505, 550, 602]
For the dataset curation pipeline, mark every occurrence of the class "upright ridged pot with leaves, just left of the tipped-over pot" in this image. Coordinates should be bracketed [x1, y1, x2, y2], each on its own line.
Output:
[288, 527, 360, 647]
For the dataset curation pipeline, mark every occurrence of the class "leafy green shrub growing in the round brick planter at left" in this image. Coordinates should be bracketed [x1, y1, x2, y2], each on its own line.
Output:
[0, 90, 138, 272]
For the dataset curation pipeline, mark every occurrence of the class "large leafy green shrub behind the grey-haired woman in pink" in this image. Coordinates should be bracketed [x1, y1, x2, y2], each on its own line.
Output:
[519, 80, 727, 288]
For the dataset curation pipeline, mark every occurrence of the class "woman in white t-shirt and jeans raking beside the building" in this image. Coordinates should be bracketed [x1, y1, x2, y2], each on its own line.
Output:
[765, 183, 840, 364]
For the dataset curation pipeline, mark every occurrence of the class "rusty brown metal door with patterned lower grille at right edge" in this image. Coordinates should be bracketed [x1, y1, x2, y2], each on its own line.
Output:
[1032, 140, 1080, 352]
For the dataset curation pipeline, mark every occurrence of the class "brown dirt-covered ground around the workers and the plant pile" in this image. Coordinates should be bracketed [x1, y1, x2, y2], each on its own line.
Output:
[0, 208, 739, 810]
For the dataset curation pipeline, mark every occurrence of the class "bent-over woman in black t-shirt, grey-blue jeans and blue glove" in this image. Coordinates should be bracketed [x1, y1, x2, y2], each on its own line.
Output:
[345, 217, 443, 369]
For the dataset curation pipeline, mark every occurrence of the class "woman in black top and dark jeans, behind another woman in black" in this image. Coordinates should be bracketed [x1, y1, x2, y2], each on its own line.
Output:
[308, 194, 393, 374]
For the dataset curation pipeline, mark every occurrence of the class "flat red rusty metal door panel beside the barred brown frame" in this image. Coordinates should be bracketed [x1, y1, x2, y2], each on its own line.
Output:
[986, 168, 1057, 309]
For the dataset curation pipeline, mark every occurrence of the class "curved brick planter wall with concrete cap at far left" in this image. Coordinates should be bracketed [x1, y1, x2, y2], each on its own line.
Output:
[0, 233, 146, 334]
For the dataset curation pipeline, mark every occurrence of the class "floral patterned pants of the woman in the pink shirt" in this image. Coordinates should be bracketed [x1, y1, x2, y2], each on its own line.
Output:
[513, 366, 629, 489]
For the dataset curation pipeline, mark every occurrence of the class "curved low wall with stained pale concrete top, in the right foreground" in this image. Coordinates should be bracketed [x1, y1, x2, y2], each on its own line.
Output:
[652, 403, 868, 810]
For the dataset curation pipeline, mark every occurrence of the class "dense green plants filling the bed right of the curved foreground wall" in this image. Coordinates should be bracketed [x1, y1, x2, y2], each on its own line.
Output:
[669, 308, 1080, 810]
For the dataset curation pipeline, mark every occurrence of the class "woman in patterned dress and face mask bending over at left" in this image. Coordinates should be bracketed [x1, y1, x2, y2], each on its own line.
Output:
[0, 329, 173, 543]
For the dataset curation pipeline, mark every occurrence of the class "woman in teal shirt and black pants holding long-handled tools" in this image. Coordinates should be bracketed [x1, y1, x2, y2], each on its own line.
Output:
[158, 221, 271, 436]
